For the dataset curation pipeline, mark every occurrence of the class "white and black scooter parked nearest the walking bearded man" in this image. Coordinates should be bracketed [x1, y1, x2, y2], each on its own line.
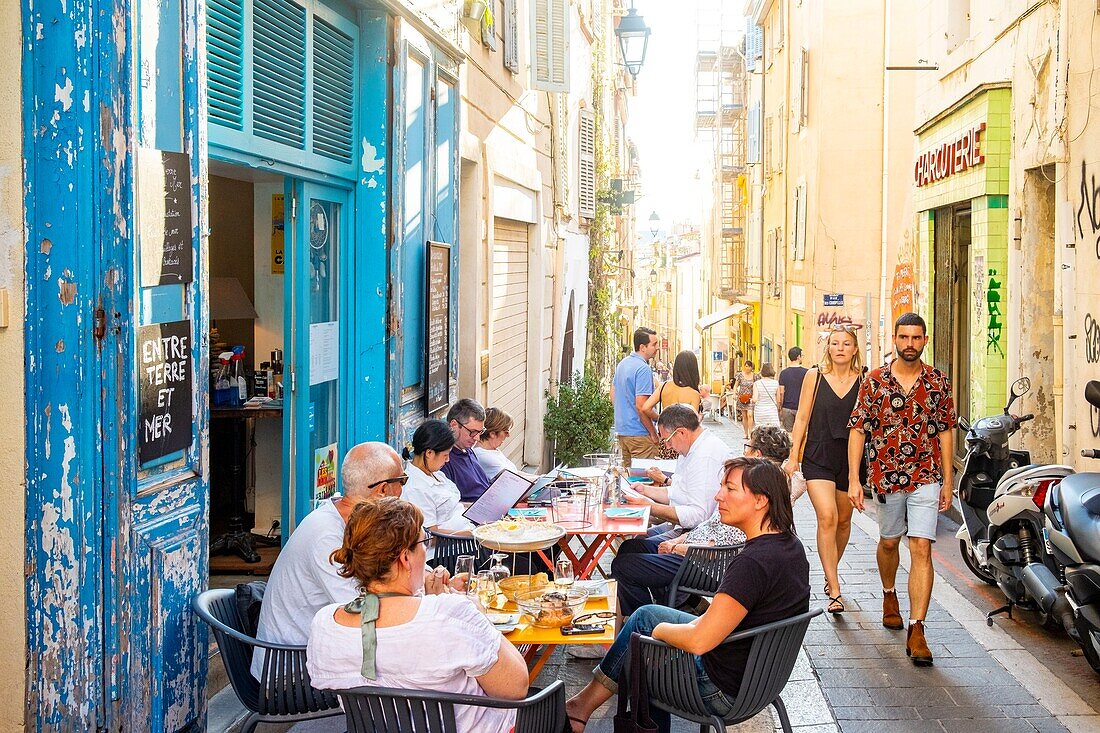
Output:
[956, 376, 1074, 625]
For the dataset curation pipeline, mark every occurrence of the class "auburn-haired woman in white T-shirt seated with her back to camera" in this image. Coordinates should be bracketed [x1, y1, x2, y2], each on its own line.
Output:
[306, 497, 527, 733]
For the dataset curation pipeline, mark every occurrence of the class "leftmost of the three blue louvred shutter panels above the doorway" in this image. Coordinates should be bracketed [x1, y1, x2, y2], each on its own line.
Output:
[207, 0, 244, 130]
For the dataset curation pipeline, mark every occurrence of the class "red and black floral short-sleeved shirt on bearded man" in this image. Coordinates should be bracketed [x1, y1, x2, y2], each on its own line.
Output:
[848, 364, 958, 494]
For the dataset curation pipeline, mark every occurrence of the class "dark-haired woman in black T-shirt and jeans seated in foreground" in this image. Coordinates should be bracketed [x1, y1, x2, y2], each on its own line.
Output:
[565, 458, 810, 733]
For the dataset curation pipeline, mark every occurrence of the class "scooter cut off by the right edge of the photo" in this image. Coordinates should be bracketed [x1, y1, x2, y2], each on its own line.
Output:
[1024, 381, 1100, 672]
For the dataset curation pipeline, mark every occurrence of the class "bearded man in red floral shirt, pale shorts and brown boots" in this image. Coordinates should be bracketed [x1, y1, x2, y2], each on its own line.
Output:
[848, 313, 957, 667]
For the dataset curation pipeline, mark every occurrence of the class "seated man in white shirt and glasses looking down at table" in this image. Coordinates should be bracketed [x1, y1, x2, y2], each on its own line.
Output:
[619, 404, 732, 528]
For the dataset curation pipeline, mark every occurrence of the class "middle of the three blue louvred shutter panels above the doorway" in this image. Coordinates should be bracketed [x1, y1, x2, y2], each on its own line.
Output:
[252, 0, 306, 150]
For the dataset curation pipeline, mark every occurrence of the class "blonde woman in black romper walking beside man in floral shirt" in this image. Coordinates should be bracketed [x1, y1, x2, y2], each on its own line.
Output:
[783, 325, 866, 613]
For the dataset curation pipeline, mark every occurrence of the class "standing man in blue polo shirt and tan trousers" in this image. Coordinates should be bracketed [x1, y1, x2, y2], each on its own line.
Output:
[612, 326, 660, 467]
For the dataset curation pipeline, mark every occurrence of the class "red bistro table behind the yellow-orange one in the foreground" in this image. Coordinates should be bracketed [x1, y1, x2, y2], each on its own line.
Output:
[539, 499, 649, 576]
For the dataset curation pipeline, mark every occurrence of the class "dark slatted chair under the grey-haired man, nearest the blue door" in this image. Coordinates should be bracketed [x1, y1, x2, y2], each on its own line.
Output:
[191, 588, 341, 733]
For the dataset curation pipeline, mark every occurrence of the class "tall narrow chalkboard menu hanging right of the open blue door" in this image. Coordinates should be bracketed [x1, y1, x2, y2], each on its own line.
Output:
[424, 242, 451, 415]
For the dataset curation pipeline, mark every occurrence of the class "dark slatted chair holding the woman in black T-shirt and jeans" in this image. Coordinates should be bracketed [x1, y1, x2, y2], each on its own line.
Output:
[630, 609, 824, 733]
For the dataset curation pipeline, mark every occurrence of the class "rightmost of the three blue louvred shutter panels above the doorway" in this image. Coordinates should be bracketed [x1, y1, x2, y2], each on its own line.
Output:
[314, 17, 355, 163]
